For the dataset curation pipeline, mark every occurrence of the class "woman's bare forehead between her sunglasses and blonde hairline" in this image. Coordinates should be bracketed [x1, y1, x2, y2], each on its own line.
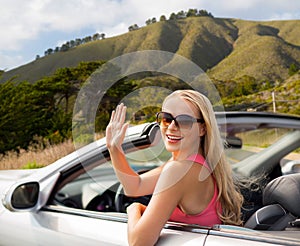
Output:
[162, 96, 199, 116]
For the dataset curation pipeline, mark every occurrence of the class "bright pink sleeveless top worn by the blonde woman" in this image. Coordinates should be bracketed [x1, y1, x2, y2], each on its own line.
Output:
[169, 154, 222, 227]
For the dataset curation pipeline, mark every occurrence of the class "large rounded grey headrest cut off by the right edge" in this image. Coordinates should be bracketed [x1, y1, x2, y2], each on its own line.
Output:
[263, 173, 300, 217]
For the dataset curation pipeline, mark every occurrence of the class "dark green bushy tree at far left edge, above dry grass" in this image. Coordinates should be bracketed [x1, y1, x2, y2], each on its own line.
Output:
[0, 81, 54, 153]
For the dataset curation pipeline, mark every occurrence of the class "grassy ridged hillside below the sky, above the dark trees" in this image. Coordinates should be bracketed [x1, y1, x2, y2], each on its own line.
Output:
[0, 17, 300, 82]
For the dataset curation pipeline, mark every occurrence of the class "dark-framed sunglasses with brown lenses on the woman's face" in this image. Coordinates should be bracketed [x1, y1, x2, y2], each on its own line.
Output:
[156, 112, 204, 130]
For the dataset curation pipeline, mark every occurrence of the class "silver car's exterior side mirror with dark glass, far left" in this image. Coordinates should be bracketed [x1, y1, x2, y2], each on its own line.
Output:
[3, 182, 40, 211]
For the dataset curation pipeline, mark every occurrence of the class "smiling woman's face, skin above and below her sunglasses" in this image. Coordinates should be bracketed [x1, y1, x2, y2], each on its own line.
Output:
[161, 96, 205, 159]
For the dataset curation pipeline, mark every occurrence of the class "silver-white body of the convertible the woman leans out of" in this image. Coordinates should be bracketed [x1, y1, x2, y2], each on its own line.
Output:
[0, 112, 300, 246]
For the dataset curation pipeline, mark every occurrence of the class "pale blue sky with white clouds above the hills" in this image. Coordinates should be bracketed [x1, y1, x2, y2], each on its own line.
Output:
[0, 0, 300, 71]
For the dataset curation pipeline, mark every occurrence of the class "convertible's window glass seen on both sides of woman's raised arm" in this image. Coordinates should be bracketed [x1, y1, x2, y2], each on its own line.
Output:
[54, 134, 170, 212]
